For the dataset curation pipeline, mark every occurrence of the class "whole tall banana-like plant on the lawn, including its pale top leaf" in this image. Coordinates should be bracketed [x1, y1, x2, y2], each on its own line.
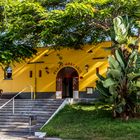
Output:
[96, 17, 140, 118]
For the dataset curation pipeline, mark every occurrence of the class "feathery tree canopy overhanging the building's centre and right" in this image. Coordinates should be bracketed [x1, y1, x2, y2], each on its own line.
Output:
[41, 0, 140, 48]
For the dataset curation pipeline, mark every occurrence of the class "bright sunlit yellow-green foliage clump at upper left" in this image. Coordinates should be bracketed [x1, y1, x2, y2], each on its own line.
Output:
[5, 1, 46, 43]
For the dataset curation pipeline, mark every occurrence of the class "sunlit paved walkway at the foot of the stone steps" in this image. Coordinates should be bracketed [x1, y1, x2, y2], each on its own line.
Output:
[0, 132, 61, 140]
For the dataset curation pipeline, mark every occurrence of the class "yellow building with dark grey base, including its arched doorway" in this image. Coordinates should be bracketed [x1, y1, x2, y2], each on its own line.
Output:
[0, 42, 110, 98]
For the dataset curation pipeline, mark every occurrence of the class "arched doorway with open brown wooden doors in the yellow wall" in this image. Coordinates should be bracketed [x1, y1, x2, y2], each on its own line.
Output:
[56, 67, 79, 98]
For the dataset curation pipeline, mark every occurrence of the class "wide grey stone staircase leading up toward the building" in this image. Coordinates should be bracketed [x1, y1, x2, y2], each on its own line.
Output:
[0, 99, 64, 134]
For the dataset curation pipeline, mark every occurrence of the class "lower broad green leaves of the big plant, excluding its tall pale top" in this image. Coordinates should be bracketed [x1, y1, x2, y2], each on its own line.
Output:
[97, 50, 140, 117]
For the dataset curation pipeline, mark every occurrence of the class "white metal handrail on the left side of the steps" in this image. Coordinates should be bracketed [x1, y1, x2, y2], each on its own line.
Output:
[0, 85, 33, 115]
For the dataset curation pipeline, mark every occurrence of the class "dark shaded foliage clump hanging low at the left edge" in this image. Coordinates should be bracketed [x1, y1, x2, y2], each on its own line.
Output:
[0, 33, 37, 69]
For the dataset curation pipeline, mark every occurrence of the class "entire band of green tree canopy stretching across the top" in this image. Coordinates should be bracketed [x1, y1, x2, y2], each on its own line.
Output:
[0, 0, 140, 65]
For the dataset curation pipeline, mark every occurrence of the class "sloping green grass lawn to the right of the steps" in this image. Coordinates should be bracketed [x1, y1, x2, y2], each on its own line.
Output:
[42, 105, 140, 140]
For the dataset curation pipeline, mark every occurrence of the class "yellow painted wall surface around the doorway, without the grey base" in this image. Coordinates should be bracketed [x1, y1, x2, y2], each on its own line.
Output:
[0, 42, 111, 93]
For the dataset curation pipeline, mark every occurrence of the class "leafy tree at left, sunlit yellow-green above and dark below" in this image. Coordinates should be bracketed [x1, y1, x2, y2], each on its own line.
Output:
[0, 0, 46, 69]
